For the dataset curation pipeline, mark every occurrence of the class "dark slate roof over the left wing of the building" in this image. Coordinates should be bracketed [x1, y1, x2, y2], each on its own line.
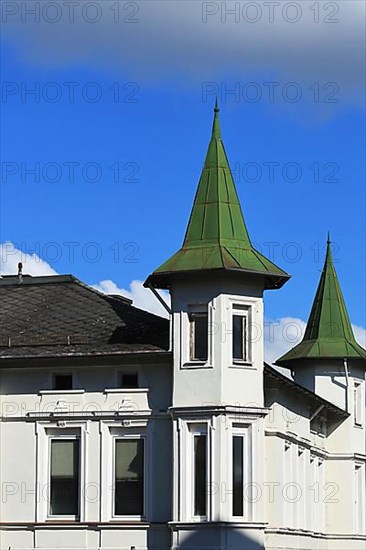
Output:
[0, 275, 169, 360]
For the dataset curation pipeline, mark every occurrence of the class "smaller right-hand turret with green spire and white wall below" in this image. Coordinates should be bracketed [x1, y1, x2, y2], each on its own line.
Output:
[276, 235, 366, 440]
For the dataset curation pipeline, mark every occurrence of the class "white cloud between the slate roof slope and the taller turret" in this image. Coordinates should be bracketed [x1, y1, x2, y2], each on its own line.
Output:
[93, 280, 170, 317]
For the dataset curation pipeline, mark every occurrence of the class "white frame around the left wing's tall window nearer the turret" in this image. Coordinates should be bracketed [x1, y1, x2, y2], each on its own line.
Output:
[110, 431, 148, 521]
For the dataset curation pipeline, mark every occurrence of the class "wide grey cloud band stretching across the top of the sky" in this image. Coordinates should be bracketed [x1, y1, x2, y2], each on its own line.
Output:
[3, 0, 365, 105]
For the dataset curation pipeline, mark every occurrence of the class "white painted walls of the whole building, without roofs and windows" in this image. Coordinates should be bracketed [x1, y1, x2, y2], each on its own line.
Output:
[0, 304, 366, 550]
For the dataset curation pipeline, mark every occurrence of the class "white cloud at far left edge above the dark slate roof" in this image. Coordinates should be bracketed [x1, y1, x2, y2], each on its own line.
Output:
[0, 242, 57, 277]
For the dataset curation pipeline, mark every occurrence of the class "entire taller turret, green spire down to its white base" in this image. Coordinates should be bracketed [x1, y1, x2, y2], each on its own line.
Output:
[145, 104, 289, 548]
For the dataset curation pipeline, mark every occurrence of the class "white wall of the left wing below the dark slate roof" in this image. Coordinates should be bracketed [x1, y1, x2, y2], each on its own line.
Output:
[0, 364, 172, 550]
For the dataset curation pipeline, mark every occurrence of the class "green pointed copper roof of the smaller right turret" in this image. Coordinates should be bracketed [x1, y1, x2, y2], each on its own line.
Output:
[276, 237, 366, 365]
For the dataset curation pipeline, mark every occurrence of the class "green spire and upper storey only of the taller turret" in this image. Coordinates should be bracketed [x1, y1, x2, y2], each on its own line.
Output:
[145, 103, 289, 406]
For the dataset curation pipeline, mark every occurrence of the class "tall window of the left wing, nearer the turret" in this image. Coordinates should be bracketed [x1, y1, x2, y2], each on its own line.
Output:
[114, 438, 145, 516]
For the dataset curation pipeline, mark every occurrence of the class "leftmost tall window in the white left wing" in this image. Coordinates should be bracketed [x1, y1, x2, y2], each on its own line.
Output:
[49, 438, 80, 516]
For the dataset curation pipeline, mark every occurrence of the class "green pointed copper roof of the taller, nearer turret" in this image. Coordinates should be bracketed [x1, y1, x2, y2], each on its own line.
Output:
[146, 102, 290, 294]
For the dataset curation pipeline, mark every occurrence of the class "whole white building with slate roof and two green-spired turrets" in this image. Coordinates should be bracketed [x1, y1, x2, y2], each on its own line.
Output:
[0, 107, 366, 550]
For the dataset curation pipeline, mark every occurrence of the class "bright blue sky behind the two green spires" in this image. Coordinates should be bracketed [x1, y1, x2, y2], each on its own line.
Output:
[0, 2, 366, 344]
